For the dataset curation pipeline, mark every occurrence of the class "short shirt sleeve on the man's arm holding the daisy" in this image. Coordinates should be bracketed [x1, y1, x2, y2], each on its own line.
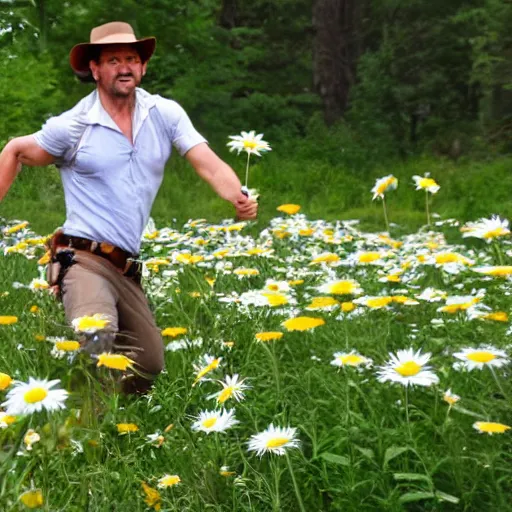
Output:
[158, 98, 207, 156]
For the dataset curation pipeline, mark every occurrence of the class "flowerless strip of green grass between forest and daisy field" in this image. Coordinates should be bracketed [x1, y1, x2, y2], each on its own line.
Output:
[0, 148, 512, 233]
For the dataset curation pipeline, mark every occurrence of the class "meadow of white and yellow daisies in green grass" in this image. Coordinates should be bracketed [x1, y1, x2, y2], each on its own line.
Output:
[0, 188, 512, 512]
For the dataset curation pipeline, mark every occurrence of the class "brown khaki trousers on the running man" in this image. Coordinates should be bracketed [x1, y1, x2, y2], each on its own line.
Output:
[61, 251, 164, 379]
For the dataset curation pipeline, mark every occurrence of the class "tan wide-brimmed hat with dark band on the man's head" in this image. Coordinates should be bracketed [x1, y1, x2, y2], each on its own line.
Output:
[69, 21, 156, 78]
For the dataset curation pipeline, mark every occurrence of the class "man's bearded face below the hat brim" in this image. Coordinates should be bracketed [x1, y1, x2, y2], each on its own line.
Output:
[90, 44, 147, 98]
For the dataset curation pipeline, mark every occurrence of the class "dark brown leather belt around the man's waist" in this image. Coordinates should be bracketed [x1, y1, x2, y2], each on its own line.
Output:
[50, 231, 142, 283]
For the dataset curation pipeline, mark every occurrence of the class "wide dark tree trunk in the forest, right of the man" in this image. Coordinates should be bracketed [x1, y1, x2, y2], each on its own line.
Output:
[313, 0, 363, 125]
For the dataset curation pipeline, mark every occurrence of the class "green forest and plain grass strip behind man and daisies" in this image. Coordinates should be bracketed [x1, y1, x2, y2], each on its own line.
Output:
[0, 0, 512, 232]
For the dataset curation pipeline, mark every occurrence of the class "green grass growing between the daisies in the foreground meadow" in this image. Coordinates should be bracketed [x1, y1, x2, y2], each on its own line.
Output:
[0, 210, 512, 512]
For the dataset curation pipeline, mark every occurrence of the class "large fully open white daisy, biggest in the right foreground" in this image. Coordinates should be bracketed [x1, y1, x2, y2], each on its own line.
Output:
[378, 348, 439, 386]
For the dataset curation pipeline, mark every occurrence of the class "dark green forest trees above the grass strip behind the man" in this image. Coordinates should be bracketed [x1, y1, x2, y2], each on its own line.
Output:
[0, 0, 512, 165]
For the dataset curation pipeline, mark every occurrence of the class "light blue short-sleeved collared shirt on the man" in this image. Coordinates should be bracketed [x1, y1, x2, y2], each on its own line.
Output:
[34, 88, 206, 254]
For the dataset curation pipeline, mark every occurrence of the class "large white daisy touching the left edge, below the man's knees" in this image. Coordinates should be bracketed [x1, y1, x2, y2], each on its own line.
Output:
[2, 377, 68, 416]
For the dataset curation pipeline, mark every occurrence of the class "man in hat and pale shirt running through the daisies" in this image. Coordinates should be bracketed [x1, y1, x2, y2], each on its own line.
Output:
[0, 22, 257, 392]
